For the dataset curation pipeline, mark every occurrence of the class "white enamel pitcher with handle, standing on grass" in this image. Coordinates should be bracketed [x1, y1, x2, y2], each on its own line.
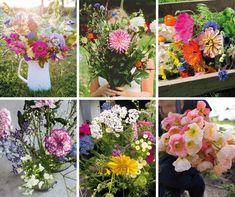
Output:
[18, 59, 51, 91]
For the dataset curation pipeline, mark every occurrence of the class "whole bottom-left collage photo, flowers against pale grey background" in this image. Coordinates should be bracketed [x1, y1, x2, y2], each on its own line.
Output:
[0, 100, 77, 197]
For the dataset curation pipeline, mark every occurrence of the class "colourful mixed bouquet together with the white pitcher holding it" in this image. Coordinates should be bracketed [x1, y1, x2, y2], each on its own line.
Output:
[0, 3, 76, 91]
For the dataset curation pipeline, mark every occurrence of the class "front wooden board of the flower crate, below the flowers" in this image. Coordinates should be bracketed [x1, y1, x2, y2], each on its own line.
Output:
[159, 70, 235, 97]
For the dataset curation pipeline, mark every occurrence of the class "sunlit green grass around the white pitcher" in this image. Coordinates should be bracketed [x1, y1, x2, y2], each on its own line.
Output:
[0, 42, 77, 97]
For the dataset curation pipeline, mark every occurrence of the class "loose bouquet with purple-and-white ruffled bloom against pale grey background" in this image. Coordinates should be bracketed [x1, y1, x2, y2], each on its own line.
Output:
[0, 100, 76, 195]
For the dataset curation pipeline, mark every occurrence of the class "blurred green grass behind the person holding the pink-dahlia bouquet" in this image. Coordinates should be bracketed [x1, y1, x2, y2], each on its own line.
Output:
[79, 36, 156, 97]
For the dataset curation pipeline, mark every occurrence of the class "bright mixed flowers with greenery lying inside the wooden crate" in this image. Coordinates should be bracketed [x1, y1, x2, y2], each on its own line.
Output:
[158, 4, 235, 80]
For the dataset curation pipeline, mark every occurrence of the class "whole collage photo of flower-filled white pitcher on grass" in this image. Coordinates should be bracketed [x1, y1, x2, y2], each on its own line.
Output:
[0, 0, 77, 97]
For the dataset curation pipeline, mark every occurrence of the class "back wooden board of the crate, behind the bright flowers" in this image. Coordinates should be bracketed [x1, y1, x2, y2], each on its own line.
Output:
[159, 0, 235, 18]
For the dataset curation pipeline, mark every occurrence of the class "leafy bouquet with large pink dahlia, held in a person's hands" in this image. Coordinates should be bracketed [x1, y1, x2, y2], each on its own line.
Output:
[80, 3, 156, 89]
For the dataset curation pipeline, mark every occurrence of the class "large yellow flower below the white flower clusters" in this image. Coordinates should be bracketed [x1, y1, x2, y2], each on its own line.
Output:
[107, 155, 139, 176]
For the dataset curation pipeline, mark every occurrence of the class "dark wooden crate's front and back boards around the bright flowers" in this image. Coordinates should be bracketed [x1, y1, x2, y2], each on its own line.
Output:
[159, 0, 235, 97]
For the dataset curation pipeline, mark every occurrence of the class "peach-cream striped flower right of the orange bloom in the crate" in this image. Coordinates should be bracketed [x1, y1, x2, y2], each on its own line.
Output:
[199, 27, 223, 58]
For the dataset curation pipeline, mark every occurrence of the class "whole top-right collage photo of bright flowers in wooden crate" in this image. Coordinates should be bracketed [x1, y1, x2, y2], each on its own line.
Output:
[158, 0, 235, 97]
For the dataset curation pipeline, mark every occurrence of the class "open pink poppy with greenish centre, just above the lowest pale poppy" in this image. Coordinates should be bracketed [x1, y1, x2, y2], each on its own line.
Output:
[169, 134, 187, 157]
